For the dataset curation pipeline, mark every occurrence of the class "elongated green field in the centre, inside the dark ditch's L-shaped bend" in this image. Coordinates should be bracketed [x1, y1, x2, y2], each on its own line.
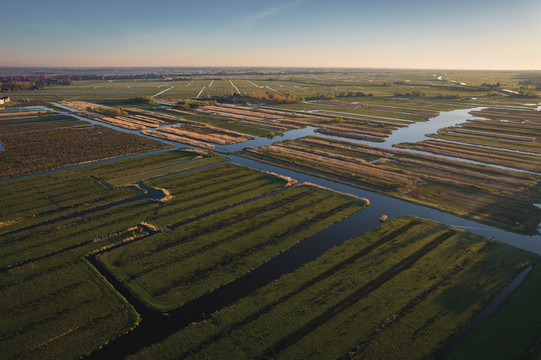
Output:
[98, 184, 365, 310]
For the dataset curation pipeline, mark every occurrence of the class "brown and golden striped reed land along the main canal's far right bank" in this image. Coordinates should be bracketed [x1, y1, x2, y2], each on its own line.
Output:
[240, 137, 541, 233]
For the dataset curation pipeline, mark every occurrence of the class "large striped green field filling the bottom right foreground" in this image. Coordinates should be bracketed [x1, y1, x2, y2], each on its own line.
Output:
[130, 216, 541, 359]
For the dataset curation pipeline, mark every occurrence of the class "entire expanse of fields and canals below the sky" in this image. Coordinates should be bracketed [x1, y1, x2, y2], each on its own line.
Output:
[0, 68, 541, 359]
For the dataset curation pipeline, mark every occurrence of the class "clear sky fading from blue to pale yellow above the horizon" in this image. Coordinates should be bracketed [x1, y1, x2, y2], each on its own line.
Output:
[0, 0, 541, 70]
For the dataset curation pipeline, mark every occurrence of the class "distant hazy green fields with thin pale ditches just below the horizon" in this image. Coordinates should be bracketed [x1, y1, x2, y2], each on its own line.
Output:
[5, 69, 541, 102]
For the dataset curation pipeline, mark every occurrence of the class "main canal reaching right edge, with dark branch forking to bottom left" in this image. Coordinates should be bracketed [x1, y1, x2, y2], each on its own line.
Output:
[84, 156, 541, 359]
